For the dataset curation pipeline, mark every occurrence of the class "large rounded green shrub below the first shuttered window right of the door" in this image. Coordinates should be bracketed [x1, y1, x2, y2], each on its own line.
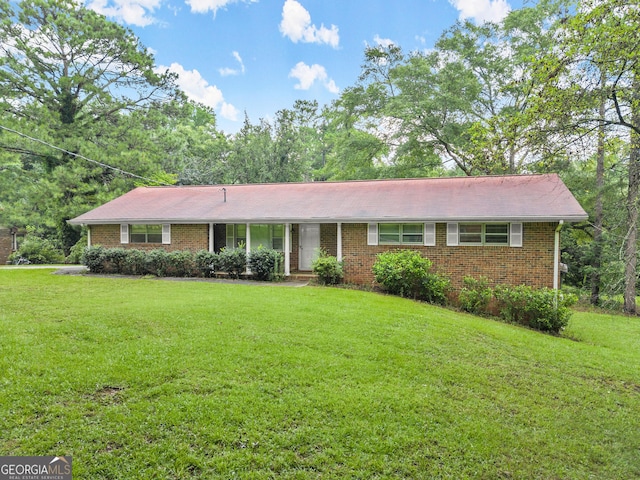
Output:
[373, 250, 431, 298]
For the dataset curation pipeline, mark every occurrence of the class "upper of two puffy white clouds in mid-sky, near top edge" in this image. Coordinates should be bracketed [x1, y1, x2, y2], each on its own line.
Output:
[280, 0, 340, 48]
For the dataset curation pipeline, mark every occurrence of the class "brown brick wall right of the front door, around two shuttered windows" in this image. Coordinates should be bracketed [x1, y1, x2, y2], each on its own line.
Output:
[342, 223, 556, 288]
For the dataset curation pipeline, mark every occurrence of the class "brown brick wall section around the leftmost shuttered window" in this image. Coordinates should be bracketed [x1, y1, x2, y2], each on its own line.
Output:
[91, 224, 209, 252]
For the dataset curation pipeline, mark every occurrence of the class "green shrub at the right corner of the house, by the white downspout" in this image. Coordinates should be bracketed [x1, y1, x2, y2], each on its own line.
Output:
[495, 285, 577, 333]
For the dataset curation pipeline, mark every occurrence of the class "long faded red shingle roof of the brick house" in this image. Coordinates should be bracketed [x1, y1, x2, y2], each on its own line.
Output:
[70, 174, 587, 224]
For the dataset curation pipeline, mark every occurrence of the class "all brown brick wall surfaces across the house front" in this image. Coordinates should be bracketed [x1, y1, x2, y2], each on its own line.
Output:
[89, 222, 558, 288]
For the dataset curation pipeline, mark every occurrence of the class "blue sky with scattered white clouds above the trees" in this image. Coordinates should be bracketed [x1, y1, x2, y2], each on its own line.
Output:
[87, 0, 526, 133]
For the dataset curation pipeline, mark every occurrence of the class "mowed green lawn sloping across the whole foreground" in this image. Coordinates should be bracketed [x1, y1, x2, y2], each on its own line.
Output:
[0, 269, 640, 479]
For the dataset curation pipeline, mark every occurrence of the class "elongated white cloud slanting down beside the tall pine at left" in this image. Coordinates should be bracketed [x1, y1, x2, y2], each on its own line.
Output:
[156, 63, 238, 121]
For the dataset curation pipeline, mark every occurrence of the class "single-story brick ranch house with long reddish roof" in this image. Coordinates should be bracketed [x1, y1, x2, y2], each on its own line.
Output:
[70, 174, 587, 288]
